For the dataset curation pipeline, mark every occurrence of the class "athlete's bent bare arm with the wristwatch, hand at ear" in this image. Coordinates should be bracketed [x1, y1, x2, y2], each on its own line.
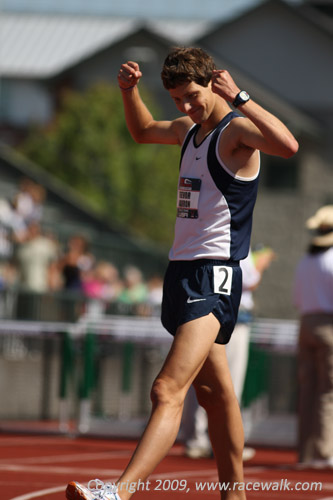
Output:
[212, 70, 298, 158]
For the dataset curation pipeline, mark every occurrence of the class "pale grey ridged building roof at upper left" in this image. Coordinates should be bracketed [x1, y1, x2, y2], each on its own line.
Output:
[0, 13, 212, 78]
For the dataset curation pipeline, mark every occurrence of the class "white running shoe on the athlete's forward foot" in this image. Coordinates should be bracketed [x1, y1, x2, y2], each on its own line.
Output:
[66, 479, 121, 500]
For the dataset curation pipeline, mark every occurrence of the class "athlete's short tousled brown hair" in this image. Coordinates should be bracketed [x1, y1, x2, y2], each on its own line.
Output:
[161, 47, 216, 90]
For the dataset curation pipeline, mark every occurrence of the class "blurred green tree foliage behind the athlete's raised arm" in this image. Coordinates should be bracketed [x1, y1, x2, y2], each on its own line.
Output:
[21, 84, 179, 244]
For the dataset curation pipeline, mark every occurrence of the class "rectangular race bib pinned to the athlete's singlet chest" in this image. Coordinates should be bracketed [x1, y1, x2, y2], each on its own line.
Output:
[177, 177, 201, 219]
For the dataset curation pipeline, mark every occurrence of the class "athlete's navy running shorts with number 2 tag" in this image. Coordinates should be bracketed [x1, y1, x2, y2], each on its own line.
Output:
[161, 259, 242, 344]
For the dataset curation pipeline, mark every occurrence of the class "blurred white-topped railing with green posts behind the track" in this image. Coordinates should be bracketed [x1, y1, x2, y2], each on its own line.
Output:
[0, 313, 297, 444]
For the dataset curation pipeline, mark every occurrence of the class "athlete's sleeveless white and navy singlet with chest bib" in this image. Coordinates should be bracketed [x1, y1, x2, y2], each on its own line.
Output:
[169, 111, 259, 261]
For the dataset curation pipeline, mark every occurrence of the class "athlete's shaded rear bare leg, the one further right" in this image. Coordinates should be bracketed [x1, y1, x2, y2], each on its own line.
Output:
[193, 344, 246, 500]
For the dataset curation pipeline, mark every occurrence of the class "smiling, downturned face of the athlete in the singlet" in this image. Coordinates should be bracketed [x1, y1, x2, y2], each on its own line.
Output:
[169, 82, 215, 123]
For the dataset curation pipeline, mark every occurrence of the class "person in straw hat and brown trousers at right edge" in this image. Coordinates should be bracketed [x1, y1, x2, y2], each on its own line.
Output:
[294, 205, 333, 467]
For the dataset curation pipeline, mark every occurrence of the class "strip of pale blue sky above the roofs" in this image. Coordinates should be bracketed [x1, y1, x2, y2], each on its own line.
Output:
[0, 0, 300, 20]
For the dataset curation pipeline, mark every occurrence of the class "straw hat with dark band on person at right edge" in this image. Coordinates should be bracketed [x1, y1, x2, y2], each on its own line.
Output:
[306, 205, 333, 247]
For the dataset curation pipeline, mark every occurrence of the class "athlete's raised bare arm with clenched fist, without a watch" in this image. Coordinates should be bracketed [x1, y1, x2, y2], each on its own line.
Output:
[118, 61, 193, 145]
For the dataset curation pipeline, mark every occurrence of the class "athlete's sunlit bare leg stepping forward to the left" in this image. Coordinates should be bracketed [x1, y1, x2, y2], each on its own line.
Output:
[114, 314, 220, 500]
